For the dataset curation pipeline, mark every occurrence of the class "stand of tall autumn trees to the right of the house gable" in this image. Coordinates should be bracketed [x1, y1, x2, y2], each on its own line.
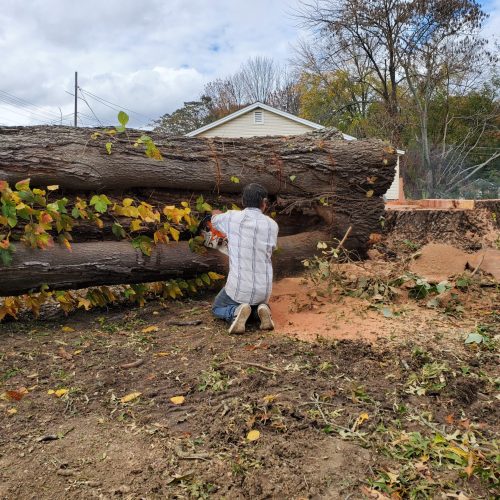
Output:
[294, 0, 499, 196]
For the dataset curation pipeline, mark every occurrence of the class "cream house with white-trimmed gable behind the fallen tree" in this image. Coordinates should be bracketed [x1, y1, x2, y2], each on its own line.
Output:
[186, 102, 404, 200]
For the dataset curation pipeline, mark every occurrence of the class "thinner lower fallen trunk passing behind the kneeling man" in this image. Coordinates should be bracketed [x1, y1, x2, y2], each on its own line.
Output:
[0, 231, 329, 296]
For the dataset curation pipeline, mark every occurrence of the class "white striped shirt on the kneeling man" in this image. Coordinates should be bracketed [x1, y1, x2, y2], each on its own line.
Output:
[212, 208, 278, 305]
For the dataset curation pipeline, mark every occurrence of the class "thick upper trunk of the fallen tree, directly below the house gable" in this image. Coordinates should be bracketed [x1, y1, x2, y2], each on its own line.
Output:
[0, 126, 396, 196]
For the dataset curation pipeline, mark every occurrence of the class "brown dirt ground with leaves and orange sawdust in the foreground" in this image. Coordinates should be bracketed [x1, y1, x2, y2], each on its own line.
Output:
[0, 248, 500, 500]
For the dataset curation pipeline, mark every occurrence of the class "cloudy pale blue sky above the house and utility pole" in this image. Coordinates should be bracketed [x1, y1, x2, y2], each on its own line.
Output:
[0, 0, 500, 127]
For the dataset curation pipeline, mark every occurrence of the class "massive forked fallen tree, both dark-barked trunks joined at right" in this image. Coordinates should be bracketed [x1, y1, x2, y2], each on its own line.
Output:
[0, 126, 396, 295]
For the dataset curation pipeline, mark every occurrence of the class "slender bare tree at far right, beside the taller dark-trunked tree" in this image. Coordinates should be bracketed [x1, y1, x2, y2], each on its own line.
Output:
[398, 0, 498, 196]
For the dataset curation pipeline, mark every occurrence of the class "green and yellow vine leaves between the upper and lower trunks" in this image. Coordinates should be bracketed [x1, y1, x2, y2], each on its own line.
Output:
[0, 179, 217, 266]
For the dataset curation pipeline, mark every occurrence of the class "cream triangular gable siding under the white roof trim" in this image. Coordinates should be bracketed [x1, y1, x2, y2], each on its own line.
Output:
[198, 109, 314, 137]
